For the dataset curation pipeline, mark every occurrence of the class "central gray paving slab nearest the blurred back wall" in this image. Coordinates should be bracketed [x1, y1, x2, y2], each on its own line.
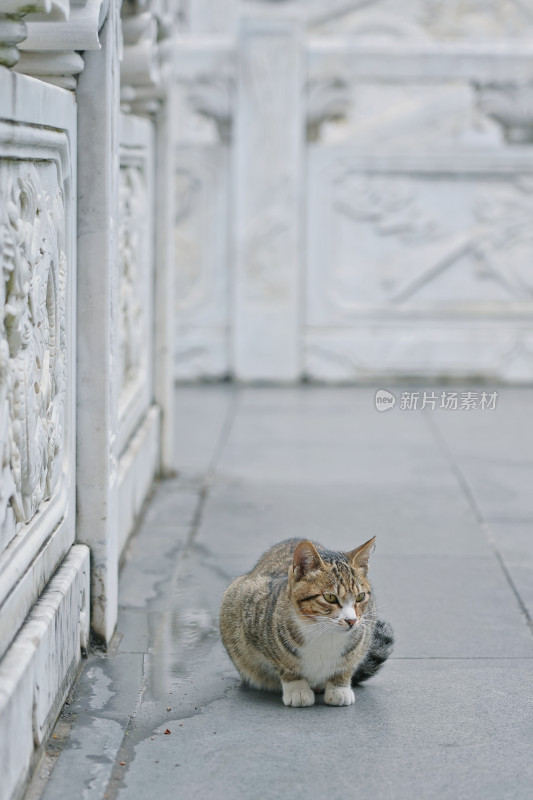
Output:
[216, 404, 455, 487]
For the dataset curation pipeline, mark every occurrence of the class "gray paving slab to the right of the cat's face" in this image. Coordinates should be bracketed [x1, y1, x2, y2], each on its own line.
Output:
[371, 554, 533, 658]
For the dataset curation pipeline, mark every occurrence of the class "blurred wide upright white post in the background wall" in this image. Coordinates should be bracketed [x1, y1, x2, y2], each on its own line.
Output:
[233, 16, 305, 381]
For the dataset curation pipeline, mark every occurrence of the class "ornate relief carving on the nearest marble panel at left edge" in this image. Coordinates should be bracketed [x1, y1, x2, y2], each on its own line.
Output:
[0, 162, 67, 535]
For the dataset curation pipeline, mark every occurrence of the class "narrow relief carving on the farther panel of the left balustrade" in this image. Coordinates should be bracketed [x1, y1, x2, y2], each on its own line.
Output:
[118, 166, 148, 406]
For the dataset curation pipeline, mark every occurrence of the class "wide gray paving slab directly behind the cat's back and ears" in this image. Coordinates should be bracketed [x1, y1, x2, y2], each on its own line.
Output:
[196, 483, 490, 560]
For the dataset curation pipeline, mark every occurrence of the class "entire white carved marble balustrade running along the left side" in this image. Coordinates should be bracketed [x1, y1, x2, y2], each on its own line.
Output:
[0, 0, 177, 800]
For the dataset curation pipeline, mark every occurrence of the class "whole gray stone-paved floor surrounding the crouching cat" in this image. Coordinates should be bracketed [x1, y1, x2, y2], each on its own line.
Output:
[28, 386, 533, 800]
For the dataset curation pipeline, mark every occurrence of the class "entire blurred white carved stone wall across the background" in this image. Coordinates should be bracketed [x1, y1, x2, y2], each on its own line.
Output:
[175, 0, 533, 383]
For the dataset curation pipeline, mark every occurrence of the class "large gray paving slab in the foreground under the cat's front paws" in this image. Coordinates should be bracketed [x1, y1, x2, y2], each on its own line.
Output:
[114, 660, 533, 800]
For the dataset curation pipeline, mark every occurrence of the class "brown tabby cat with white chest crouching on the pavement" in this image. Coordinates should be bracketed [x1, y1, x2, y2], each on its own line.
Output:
[220, 537, 394, 707]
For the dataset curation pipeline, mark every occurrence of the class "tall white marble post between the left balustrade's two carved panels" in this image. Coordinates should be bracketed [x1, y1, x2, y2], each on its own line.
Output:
[77, 2, 120, 643]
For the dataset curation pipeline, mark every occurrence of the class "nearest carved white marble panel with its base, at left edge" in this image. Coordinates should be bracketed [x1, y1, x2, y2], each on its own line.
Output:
[0, 68, 89, 800]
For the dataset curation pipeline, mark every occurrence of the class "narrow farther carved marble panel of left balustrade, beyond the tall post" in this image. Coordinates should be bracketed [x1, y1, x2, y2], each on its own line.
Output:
[115, 115, 160, 553]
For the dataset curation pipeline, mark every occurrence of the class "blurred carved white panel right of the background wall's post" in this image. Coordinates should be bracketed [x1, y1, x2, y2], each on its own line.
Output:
[306, 152, 533, 381]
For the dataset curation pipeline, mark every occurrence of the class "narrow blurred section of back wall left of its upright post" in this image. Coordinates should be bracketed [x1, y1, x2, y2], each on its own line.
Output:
[172, 39, 235, 380]
